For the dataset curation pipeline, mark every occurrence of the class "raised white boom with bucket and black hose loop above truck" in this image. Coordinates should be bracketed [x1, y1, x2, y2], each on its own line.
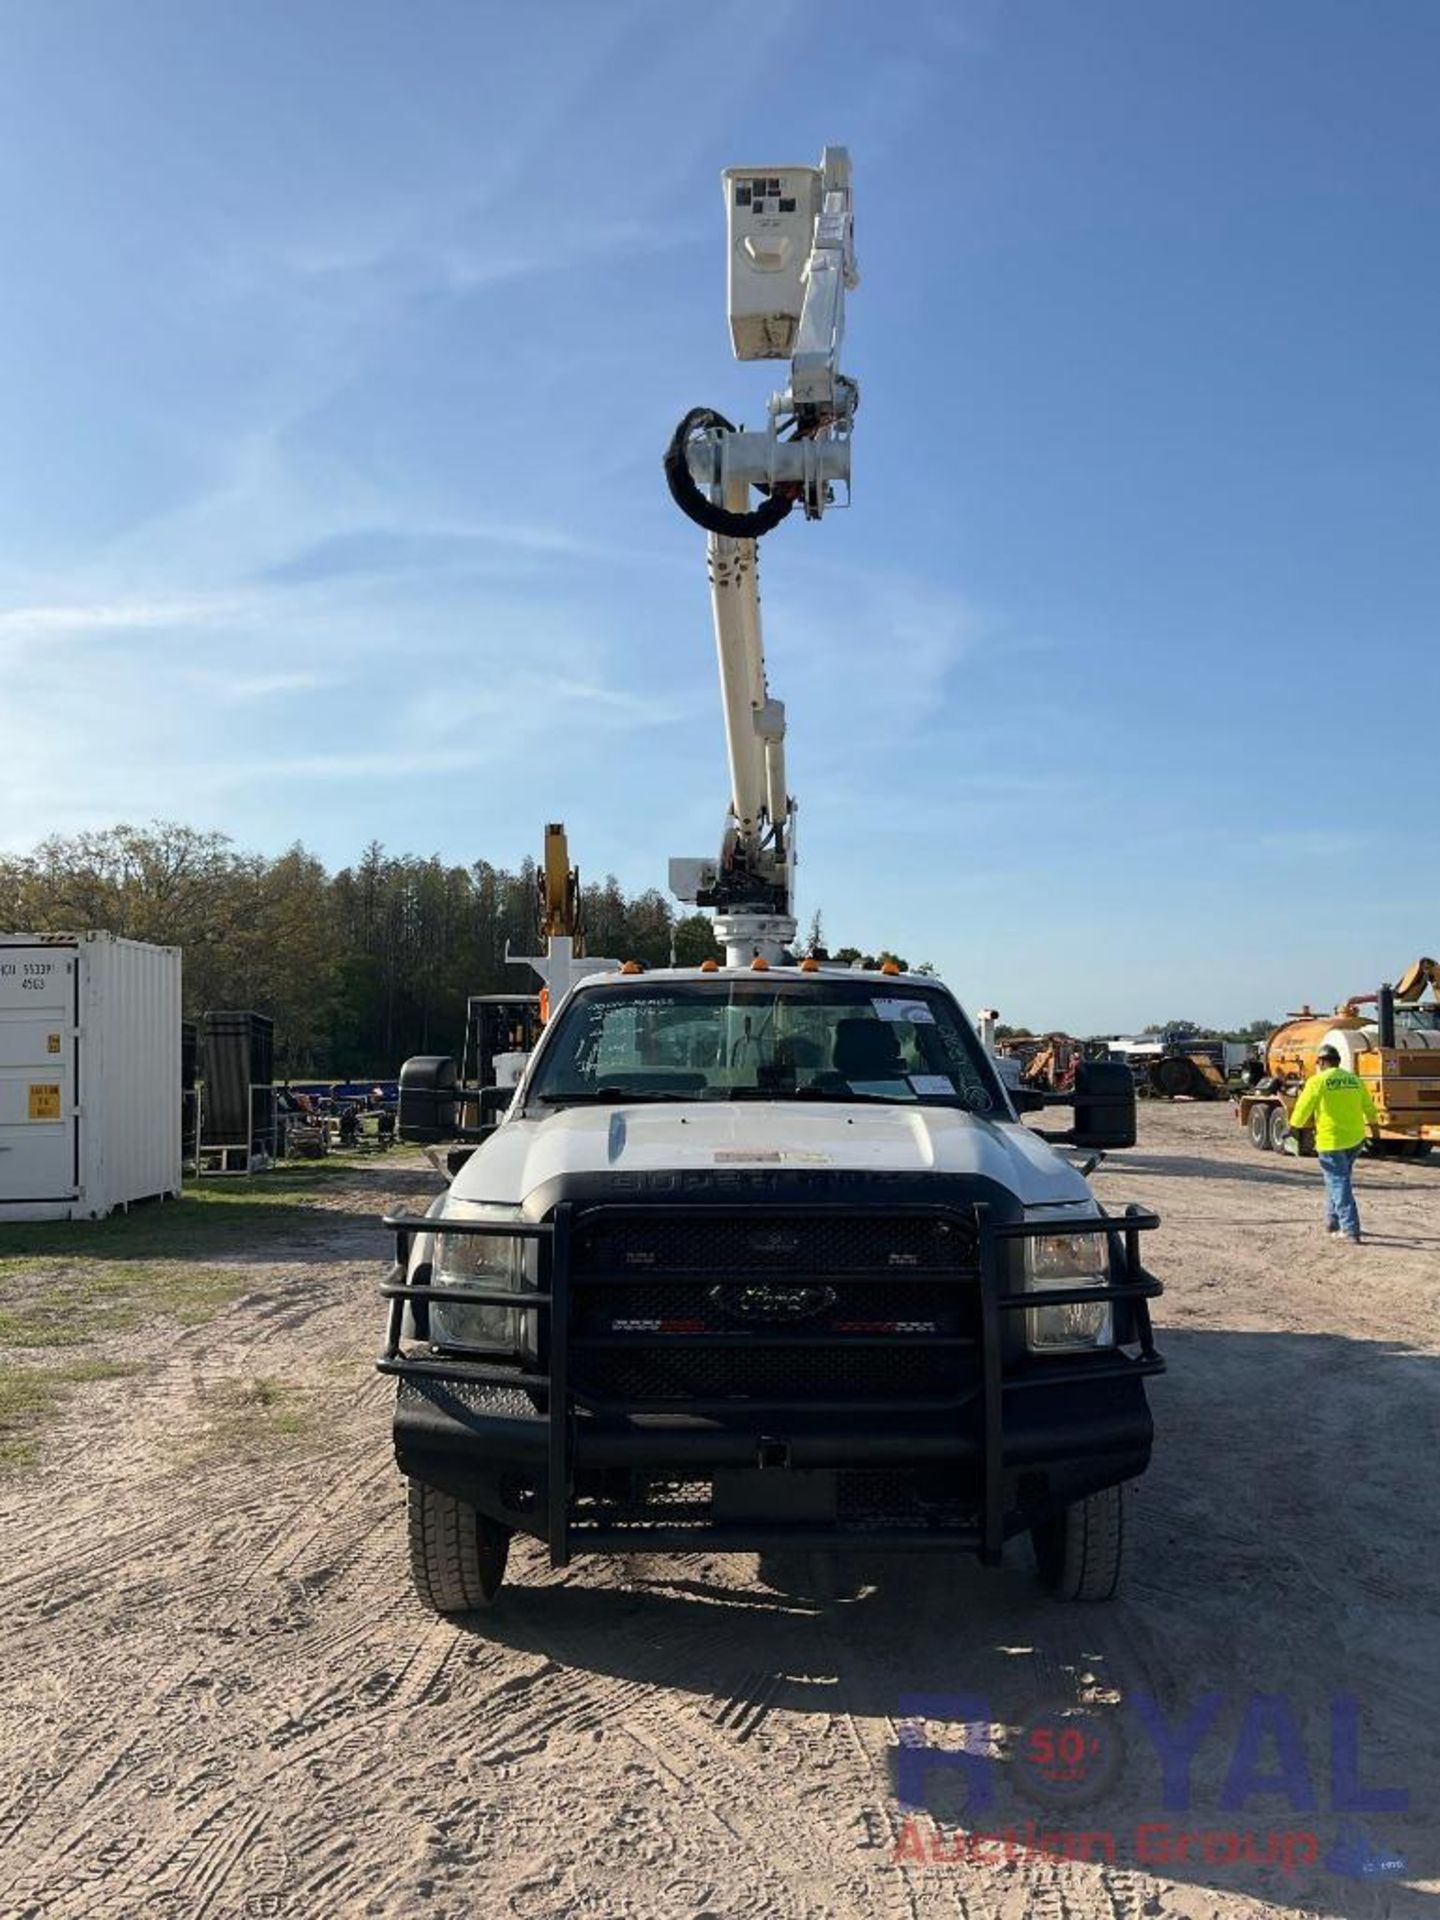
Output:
[664, 146, 860, 966]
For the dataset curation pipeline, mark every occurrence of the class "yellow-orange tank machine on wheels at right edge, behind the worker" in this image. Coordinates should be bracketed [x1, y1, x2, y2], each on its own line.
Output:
[1238, 958, 1440, 1160]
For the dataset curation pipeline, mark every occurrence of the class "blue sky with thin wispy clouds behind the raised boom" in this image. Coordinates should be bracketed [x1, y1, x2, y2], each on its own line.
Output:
[0, 0, 1440, 1031]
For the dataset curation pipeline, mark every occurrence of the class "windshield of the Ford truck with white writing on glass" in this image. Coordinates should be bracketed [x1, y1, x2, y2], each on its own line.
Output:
[526, 973, 1006, 1114]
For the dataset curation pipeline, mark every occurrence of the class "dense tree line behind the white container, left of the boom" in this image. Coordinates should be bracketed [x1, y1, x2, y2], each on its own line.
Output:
[0, 822, 720, 1079]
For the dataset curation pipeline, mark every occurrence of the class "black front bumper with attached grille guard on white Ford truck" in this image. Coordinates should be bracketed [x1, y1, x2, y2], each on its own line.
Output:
[378, 1200, 1164, 1567]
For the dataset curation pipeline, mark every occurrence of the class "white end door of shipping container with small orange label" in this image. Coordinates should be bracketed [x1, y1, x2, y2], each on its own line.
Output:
[0, 947, 79, 1206]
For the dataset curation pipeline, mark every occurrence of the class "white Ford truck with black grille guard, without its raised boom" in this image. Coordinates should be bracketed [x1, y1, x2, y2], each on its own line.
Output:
[378, 960, 1164, 1613]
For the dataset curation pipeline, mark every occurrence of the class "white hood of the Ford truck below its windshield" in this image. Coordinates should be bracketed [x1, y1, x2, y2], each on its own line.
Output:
[449, 1100, 1091, 1206]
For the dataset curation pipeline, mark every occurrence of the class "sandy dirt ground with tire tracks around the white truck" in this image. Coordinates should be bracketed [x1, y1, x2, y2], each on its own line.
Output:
[0, 1106, 1440, 1920]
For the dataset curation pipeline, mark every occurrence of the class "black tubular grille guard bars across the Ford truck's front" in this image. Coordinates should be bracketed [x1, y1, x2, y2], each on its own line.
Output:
[376, 1200, 1165, 1567]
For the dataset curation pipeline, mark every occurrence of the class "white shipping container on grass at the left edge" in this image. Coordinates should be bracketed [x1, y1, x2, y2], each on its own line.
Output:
[0, 933, 180, 1223]
